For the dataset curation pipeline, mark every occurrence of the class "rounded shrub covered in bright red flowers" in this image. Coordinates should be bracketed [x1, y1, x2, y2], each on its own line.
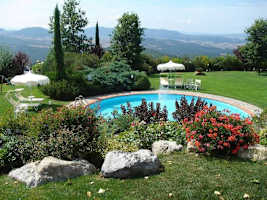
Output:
[183, 106, 259, 155]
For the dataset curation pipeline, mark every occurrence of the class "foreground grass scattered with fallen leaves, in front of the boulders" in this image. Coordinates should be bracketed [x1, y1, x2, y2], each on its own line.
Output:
[0, 152, 267, 200]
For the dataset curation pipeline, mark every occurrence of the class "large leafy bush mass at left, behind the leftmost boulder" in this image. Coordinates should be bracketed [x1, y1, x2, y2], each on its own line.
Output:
[0, 107, 100, 171]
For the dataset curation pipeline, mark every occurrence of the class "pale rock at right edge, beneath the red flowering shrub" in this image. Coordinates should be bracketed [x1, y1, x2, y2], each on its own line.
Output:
[238, 144, 267, 160]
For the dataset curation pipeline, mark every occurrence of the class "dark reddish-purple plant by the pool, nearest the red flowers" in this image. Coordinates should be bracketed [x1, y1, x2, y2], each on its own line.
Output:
[172, 96, 208, 123]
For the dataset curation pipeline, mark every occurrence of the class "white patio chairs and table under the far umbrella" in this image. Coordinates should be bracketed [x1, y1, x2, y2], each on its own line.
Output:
[160, 77, 201, 91]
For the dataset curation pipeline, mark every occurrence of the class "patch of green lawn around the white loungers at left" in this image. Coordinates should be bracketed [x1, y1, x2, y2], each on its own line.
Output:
[0, 85, 69, 115]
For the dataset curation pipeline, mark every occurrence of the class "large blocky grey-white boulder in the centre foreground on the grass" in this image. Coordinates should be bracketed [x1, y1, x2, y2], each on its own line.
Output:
[101, 150, 162, 178]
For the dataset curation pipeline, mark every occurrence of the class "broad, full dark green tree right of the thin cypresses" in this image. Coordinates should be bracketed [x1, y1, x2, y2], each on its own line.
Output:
[111, 13, 144, 69]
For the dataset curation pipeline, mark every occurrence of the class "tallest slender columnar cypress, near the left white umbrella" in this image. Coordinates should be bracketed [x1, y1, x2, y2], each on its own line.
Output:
[54, 6, 65, 80]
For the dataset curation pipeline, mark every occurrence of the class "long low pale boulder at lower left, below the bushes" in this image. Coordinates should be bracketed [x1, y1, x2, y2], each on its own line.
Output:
[8, 157, 96, 187]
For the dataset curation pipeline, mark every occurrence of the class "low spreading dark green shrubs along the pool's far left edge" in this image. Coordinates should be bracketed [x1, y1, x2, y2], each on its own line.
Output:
[41, 62, 150, 100]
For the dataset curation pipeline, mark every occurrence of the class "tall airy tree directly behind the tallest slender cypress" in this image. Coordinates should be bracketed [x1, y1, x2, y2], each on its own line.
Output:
[49, 0, 92, 53]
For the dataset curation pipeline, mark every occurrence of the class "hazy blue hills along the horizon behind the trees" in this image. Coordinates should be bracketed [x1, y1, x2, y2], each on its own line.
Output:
[0, 27, 246, 62]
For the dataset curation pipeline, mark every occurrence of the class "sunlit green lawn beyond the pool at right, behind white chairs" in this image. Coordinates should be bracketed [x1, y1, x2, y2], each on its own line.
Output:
[149, 71, 267, 108]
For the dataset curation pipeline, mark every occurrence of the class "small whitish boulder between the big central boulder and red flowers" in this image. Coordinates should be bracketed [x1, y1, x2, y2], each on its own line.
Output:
[152, 140, 183, 155]
